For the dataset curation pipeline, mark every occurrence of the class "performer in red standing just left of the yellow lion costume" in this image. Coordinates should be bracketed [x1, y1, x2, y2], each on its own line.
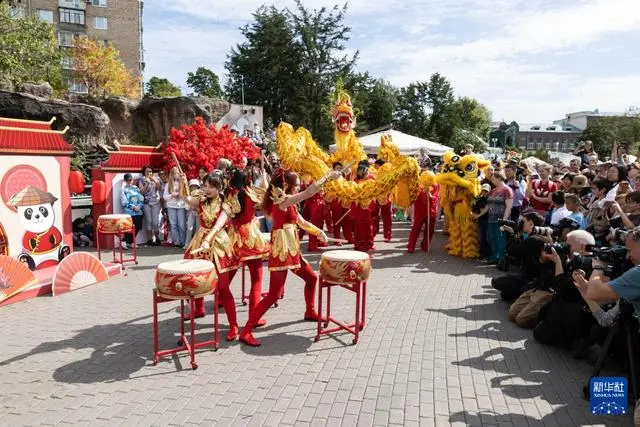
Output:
[407, 171, 439, 253]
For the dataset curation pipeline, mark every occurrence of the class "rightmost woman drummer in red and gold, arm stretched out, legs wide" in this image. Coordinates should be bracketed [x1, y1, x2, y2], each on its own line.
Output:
[240, 169, 341, 346]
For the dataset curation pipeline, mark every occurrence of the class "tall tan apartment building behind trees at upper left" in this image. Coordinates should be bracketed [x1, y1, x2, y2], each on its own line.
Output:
[21, 0, 144, 93]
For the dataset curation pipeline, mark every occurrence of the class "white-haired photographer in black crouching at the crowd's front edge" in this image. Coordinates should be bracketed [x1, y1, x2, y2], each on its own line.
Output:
[533, 230, 595, 349]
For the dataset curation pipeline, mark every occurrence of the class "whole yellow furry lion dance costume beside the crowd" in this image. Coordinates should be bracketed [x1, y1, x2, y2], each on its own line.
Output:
[436, 152, 491, 258]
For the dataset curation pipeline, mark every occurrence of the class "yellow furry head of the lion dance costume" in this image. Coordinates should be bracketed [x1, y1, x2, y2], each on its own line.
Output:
[436, 151, 491, 197]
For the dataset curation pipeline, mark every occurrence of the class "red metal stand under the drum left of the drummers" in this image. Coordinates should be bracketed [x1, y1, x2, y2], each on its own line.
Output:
[153, 289, 219, 370]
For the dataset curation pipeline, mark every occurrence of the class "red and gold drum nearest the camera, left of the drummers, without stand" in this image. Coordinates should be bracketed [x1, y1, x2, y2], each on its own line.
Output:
[156, 259, 218, 299]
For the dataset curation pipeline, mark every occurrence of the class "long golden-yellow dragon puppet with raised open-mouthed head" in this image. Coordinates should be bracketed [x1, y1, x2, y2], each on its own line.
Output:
[276, 89, 420, 208]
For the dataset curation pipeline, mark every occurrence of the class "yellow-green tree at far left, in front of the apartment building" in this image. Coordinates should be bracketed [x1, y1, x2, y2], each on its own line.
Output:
[0, 3, 62, 90]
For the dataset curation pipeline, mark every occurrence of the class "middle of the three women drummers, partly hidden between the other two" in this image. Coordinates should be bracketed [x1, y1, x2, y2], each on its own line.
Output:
[229, 169, 270, 326]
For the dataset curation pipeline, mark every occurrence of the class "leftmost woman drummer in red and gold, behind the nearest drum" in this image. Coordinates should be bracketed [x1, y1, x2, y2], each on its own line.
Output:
[182, 173, 240, 341]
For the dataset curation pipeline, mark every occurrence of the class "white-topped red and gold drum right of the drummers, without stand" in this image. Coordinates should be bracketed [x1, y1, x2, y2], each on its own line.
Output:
[320, 250, 371, 285]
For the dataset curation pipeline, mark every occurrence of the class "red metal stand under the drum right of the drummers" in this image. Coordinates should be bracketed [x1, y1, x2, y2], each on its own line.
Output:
[315, 277, 367, 344]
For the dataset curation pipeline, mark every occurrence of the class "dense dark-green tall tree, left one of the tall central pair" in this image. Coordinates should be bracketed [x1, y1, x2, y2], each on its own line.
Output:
[225, 6, 302, 124]
